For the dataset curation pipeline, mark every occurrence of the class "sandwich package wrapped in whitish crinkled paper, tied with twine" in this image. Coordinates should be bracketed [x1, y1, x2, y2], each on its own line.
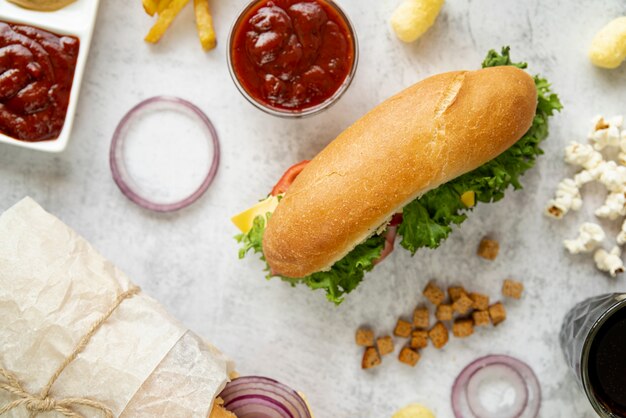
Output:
[0, 199, 232, 418]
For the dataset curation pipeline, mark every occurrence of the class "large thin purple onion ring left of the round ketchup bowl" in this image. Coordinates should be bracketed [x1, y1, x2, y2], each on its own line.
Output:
[109, 96, 220, 212]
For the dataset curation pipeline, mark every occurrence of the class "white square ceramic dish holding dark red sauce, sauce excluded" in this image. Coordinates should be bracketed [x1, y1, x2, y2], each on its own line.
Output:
[0, 0, 100, 152]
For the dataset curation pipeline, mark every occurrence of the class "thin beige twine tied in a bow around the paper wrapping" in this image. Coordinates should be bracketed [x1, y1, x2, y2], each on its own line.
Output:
[0, 286, 141, 418]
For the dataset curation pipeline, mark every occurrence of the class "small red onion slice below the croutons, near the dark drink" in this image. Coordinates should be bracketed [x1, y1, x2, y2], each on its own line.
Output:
[452, 355, 541, 418]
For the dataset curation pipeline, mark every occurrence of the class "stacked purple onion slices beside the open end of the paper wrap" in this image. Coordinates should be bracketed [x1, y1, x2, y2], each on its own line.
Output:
[219, 376, 311, 418]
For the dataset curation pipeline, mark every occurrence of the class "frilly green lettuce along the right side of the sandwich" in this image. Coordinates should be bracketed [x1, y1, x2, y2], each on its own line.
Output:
[398, 47, 562, 254]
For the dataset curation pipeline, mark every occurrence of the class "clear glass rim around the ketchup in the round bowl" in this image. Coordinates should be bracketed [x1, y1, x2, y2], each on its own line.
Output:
[226, 0, 359, 119]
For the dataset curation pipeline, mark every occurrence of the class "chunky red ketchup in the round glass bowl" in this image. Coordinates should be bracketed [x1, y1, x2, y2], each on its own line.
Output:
[230, 0, 356, 115]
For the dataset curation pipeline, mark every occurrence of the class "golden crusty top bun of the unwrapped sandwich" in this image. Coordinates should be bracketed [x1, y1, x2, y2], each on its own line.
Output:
[263, 67, 537, 278]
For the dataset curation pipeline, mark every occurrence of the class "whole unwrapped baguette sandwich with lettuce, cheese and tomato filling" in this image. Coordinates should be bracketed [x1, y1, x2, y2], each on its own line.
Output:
[232, 47, 562, 304]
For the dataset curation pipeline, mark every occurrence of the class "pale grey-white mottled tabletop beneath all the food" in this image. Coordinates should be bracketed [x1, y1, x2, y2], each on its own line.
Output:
[0, 0, 626, 418]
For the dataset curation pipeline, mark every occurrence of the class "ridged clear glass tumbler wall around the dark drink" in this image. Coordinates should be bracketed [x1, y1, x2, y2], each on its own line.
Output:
[559, 293, 626, 418]
